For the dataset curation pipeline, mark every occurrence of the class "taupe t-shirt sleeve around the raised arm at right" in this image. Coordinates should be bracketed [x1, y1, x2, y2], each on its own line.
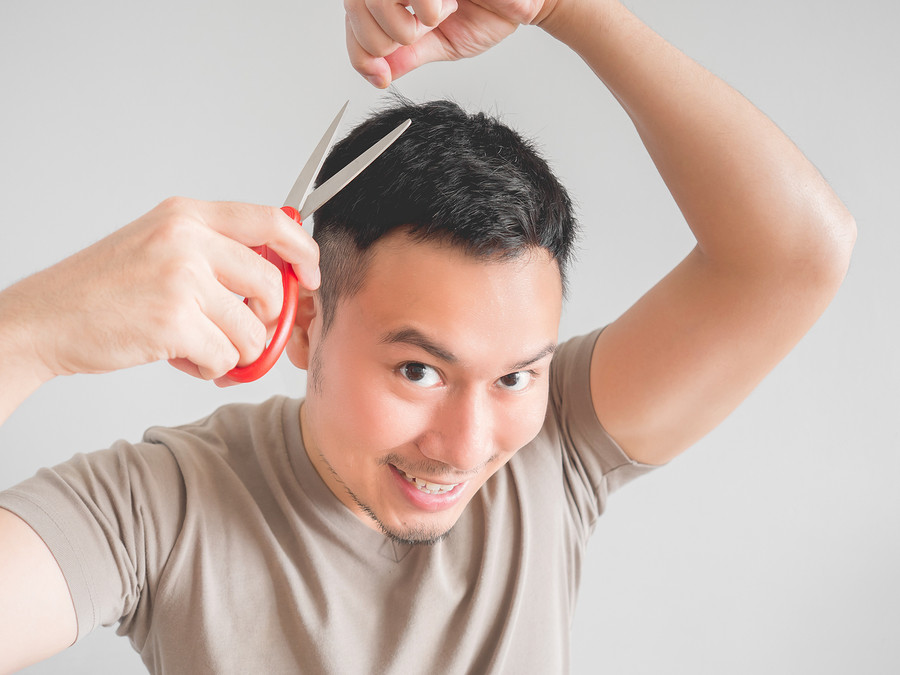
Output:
[548, 329, 655, 533]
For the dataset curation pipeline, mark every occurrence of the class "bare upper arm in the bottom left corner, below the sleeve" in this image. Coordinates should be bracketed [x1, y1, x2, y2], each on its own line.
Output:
[0, 508, 78, 673]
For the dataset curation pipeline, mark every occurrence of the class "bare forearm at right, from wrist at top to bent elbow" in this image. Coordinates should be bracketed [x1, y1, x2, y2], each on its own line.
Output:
[542, 0, 855, 275]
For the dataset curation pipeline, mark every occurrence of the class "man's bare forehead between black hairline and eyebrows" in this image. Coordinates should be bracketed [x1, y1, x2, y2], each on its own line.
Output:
[335, 231, 562, 359]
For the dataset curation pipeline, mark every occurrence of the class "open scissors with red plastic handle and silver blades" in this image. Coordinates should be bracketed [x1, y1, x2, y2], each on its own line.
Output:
[226, 101, 412, 382]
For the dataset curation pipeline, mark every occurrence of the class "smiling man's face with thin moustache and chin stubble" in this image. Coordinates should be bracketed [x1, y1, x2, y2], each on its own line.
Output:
[301, 231, 562, 542]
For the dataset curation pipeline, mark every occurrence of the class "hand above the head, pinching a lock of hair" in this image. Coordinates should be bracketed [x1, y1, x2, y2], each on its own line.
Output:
[344, 0, 557, 88]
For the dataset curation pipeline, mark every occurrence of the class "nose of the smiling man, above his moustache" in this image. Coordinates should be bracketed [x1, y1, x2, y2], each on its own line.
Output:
[419, 388, 495, 473]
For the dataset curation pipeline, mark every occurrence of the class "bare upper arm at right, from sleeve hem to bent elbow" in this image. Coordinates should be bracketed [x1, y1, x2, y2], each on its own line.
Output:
[591, 247, 846, 464]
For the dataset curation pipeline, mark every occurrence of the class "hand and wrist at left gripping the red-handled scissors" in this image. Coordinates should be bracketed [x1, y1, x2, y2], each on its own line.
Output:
[0, 198, 319, 383]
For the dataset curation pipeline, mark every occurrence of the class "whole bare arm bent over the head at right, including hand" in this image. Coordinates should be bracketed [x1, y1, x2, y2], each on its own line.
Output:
[345, 0, 855, 464]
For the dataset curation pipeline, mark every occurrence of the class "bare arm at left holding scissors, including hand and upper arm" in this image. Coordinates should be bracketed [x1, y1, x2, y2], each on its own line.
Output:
[0, 199, 318, 674]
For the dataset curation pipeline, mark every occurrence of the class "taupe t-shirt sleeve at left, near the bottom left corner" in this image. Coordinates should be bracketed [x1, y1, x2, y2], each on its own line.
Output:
[0, 442, 185, 644]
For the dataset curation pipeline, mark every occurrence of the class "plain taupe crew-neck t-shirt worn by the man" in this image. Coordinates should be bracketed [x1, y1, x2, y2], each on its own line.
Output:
[0, 333, 650, 675]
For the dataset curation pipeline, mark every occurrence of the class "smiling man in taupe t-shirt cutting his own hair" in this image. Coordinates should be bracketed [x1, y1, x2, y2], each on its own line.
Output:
[0, 0, 855, 672]
